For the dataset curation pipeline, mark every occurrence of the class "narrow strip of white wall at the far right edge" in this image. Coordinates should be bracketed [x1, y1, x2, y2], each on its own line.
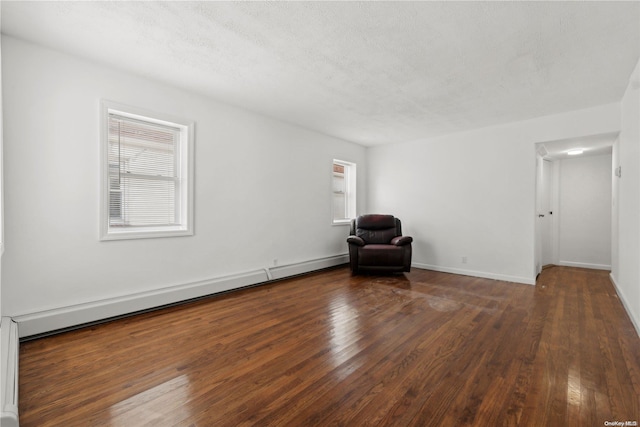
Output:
[611, 57, 640, 334]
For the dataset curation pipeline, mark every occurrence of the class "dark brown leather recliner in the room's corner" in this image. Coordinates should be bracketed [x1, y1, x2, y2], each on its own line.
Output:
[347, 215, 413, 273]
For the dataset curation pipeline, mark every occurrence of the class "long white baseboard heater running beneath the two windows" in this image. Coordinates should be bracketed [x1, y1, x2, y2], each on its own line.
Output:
[13, 254, 349, 338]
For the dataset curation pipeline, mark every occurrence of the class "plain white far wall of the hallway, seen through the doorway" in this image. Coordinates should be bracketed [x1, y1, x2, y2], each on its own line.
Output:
[554, 154, 612, 270]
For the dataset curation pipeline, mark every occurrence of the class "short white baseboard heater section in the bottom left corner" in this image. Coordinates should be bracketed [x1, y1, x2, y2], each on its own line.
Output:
[0, 317, 20, 427]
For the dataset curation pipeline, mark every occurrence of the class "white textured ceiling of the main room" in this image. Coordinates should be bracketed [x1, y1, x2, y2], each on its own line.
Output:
[1, 1, 640, 145]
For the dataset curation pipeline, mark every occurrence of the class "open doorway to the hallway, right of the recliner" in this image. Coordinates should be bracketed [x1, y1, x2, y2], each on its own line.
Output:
[534, 133, 617, 280]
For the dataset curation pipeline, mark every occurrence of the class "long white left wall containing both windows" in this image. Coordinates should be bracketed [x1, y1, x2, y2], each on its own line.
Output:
[2, 36, 366, 332]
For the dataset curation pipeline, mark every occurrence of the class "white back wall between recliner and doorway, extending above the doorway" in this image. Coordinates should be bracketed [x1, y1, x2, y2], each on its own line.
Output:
[368, 103, 620, 283]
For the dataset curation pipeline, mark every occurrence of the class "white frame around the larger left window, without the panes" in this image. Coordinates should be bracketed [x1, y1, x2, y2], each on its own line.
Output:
[100, 100, 195, 241]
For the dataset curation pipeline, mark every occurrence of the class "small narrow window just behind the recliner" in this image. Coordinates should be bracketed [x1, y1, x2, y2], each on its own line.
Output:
[332, 160, 356, 224]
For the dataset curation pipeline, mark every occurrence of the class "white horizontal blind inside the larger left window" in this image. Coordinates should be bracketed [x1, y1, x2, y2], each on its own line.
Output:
[108, 114, 180, 227]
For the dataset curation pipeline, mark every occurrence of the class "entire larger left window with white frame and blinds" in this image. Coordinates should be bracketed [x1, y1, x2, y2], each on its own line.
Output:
[101, 101, 193, 240]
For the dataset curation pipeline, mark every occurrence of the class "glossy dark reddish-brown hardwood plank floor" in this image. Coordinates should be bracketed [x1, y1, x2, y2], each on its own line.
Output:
[20, 267, 640, 427]
